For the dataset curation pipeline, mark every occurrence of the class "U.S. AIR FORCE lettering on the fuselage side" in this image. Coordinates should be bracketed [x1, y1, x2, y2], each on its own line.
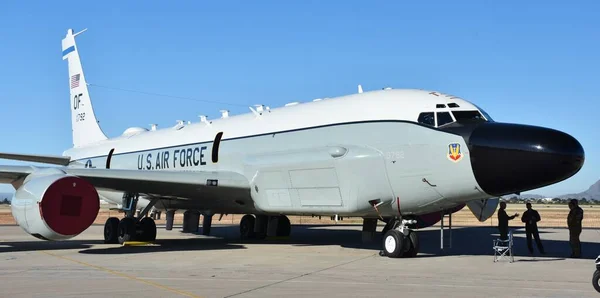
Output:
[138, 146, 207, 170]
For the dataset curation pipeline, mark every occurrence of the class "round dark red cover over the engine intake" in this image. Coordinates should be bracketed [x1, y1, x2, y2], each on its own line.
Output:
[40, 177, 100, 236]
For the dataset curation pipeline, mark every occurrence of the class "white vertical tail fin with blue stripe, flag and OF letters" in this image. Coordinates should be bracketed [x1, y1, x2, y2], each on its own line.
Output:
[62, 29, 107, 147]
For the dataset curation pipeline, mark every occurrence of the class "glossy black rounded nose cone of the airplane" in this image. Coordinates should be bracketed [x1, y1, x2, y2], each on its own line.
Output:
[468, 122, 585, 196]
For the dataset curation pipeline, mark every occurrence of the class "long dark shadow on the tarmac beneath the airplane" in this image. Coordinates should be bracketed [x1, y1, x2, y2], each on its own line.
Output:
[0, 224, 600, 262]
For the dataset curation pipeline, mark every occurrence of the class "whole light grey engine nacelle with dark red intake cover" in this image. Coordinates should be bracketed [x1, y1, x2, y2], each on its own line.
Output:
[11, 169, 100, 240]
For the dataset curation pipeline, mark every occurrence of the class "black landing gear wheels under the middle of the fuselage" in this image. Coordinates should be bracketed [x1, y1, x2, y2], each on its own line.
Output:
[240, 214, 291, 239]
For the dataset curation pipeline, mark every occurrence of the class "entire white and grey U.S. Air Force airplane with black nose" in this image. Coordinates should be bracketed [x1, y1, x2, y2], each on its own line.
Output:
[0, 29, 584, 257]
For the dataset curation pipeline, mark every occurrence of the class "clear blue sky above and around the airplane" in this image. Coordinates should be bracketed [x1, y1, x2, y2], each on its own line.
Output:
[0, 0, 600, 195]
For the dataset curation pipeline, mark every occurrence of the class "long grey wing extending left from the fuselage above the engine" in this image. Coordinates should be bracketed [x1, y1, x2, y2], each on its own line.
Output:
[0, 166, 250, 204]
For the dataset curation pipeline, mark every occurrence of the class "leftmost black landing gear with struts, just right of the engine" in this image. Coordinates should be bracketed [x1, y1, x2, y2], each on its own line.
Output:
[104, 193, 158, 244]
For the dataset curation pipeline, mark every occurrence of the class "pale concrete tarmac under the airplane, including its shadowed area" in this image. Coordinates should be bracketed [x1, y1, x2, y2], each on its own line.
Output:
[0, 224, 600, 298]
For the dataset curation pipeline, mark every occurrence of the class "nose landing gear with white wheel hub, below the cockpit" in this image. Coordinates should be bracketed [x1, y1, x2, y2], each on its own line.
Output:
[379, 219, 419, 258]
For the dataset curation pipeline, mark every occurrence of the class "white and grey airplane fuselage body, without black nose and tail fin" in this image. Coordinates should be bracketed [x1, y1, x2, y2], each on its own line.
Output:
[65, 90, 490, 216]
